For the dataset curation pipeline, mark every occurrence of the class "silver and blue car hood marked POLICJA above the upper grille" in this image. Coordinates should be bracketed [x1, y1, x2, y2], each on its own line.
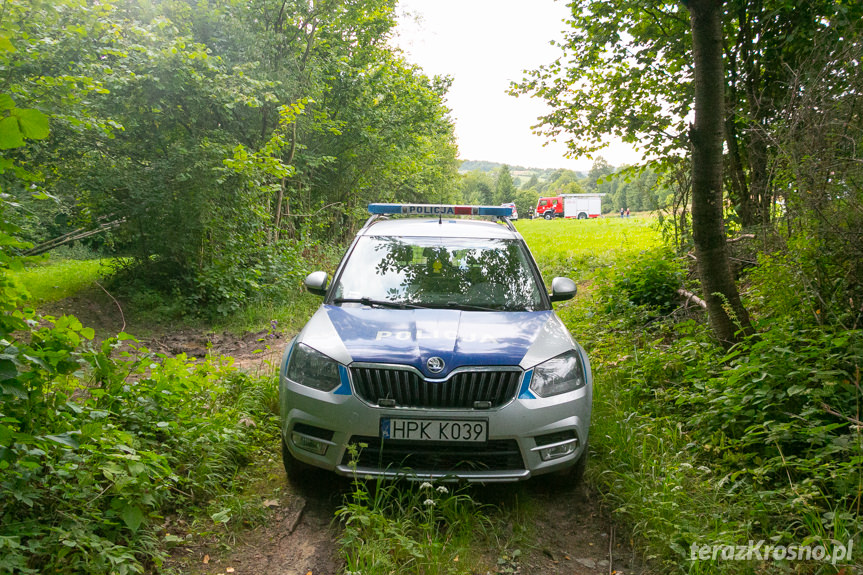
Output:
[298, 305, 574, 378]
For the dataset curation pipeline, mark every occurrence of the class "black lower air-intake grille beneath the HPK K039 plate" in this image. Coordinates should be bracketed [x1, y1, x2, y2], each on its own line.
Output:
[342, 436, 524, 473]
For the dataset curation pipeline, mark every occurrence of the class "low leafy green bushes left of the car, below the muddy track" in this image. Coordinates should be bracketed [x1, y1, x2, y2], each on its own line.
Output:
[0, 300, 277, 574]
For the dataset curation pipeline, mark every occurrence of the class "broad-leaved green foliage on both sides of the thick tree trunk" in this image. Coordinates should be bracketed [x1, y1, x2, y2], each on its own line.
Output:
[511, 0, 863, 227]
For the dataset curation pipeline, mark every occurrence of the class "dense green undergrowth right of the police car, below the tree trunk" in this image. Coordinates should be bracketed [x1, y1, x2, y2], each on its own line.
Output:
[564, 237, 863, 573]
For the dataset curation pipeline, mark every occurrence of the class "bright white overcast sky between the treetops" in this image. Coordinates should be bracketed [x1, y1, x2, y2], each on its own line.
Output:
[395, 0, 640, 172]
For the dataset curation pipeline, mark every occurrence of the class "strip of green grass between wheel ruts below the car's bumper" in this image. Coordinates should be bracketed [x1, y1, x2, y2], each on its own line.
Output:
[336, 466, 534, 575]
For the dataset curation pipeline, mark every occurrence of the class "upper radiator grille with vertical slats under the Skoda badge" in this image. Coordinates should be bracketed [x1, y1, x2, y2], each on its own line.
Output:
[351, 367, 522, 409]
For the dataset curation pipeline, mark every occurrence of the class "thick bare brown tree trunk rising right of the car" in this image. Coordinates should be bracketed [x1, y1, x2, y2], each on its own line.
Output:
[686, 0, 752, 346]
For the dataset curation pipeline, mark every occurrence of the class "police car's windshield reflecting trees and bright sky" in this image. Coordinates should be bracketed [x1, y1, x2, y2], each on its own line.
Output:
[333, 236, 544, 311]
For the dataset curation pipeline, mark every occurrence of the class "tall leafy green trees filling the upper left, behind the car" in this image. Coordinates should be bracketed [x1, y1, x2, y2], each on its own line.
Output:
[0, 0, 457, 315]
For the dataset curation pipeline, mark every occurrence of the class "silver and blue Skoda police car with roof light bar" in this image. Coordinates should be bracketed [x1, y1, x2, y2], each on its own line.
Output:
[279, 204, 593, 482]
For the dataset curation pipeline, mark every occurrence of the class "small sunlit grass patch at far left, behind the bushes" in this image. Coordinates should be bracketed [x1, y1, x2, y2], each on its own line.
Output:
[11, 259, 111, 305]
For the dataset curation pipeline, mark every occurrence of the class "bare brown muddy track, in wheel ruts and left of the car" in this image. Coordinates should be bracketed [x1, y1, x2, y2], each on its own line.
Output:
[44, 294, 648, 575]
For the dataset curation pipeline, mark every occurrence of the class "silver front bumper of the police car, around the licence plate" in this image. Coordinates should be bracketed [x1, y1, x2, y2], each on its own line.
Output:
[279, 370, 591, 482]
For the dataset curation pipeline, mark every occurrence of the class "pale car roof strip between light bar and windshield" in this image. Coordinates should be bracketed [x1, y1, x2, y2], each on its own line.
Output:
[359, 218, 521, 239]
